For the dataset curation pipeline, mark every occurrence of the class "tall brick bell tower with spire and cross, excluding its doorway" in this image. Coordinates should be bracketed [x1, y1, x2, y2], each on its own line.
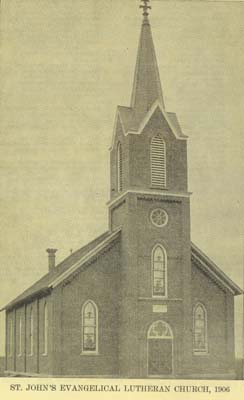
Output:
[108, 0, 192, 377]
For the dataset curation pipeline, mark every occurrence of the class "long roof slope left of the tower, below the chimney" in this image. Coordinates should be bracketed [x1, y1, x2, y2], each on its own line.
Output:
[1, 230, 120, 311]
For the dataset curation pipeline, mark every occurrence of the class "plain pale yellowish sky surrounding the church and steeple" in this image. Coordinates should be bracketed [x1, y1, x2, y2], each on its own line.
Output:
[0, 0, 244, 355]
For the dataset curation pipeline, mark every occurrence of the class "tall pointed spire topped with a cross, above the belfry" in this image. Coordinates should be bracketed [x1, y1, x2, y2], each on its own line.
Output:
[131, 0, 164, 118]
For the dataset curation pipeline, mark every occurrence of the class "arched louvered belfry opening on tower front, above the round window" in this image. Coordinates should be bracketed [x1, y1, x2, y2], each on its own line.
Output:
[151, 134, 166, 189]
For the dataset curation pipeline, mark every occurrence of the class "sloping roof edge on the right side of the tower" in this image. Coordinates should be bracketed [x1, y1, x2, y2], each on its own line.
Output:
[191, 243, 243, 296]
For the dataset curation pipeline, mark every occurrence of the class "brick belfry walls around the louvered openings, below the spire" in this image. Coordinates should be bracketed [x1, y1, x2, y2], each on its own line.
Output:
[110, 109, 187, 198]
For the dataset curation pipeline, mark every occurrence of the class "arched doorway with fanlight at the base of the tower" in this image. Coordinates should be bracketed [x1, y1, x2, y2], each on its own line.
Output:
[147, 320, 173, 376]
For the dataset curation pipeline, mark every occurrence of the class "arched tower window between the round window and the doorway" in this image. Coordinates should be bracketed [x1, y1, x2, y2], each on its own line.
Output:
[152, 245, 167, 297]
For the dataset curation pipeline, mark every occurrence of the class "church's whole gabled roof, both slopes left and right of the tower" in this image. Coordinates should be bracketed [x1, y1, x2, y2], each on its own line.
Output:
[2, 229, 243, 310]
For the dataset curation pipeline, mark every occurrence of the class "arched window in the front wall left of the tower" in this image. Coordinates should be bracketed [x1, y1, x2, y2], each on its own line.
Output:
[82, 300, 98, 354]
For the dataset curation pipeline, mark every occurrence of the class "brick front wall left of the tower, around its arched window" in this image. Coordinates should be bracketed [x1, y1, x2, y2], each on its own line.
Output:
[53, 243, 120, 376]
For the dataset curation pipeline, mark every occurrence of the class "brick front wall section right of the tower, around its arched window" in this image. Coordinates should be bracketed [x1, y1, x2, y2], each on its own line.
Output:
[192, 264, 234, 374]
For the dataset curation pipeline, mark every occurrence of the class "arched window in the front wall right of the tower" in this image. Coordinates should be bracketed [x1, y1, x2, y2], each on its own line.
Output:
[193, 303, 208, 354]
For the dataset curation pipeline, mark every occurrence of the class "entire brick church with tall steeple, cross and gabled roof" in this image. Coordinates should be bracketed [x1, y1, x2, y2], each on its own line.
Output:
[1, 0, 242, 379]
